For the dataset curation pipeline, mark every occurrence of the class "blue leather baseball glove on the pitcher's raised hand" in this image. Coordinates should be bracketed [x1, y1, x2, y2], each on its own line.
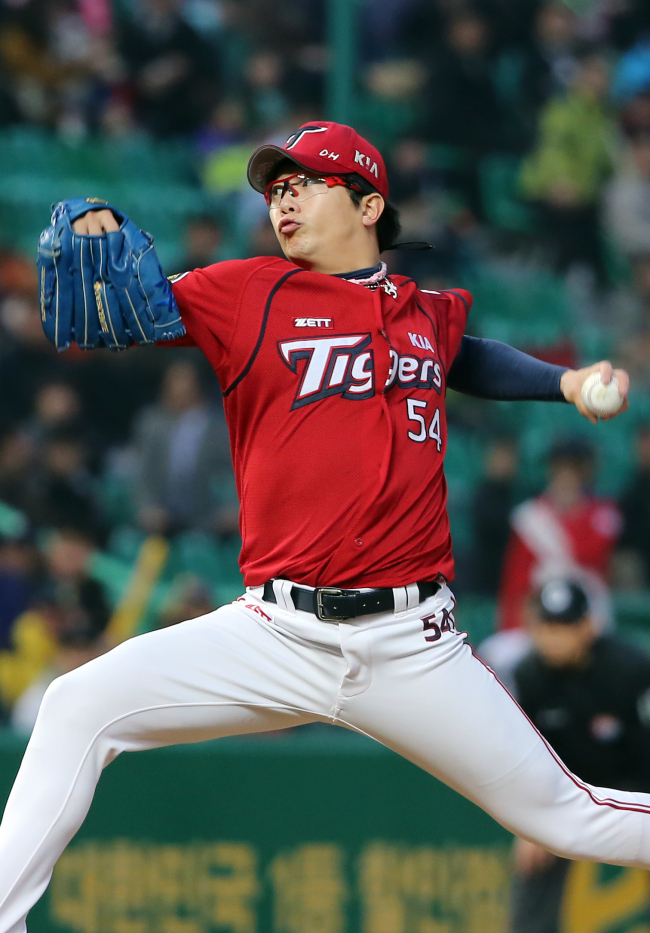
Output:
[38, 198, 185, 350]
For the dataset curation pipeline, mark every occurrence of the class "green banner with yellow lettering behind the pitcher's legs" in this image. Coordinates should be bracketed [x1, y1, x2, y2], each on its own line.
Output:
[0, 729, 650, 933]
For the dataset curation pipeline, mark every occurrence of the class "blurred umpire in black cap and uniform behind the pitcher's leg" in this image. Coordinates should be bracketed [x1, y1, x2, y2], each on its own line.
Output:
[510, 579, 650, 933]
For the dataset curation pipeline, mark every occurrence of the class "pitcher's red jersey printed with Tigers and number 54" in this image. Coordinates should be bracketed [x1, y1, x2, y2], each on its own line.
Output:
[173, 257, 471, 587]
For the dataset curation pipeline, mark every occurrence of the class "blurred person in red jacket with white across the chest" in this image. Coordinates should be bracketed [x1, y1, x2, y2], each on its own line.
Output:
[499, 438, 622, 629]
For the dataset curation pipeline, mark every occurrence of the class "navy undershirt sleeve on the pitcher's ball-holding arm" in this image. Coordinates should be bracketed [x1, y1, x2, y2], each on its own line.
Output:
[447, 336, 567, 402]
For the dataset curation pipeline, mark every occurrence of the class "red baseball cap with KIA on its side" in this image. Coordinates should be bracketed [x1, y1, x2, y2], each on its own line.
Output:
[243, 122, 388, 200]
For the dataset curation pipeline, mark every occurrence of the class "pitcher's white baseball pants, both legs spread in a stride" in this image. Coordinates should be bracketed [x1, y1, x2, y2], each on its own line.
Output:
[0, 586, 650, 933]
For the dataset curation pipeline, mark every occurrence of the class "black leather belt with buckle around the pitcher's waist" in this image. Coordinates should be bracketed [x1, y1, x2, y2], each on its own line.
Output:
[264, 580, 442, 622]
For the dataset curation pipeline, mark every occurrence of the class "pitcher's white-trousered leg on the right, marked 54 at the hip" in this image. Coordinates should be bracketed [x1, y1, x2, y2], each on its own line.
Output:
[338, 587, 650, 868]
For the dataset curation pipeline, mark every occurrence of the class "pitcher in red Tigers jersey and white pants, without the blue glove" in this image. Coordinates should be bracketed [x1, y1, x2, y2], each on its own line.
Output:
[0, 123, 650, 933]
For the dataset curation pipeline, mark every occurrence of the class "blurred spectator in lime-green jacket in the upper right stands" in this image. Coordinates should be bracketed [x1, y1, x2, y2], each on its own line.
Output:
[520, 53, 617, 284]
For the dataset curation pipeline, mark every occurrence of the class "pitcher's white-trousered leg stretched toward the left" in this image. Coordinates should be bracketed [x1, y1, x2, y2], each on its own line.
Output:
[0, 604, 345, 933]
